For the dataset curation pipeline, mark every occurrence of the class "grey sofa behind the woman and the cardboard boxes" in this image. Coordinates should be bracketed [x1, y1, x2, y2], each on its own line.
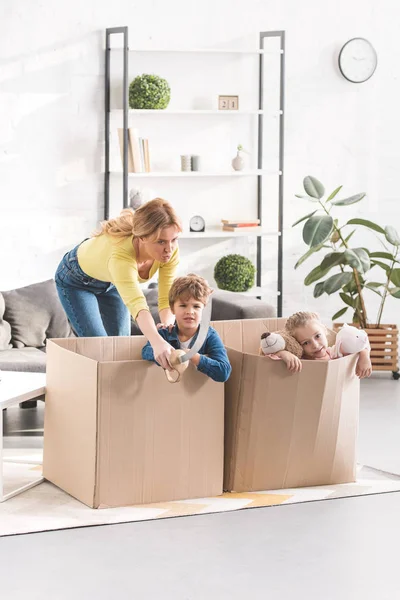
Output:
[0, 279, 276, 372]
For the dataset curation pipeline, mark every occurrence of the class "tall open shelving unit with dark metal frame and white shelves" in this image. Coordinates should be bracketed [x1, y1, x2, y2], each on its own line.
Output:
[105, 27, 285, 316]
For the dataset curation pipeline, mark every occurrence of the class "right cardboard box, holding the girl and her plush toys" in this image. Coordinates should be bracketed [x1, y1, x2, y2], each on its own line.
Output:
[213, 319, 360, 492]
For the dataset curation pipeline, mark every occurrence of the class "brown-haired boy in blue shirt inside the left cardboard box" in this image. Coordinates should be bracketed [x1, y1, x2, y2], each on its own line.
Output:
[142, 273, 232, 382]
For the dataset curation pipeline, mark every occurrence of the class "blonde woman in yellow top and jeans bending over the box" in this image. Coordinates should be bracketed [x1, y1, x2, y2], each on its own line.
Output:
[55, 198, 182, 369]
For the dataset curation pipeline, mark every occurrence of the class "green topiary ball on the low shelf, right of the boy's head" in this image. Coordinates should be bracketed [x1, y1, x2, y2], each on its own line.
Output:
[214, 254, 256, 292]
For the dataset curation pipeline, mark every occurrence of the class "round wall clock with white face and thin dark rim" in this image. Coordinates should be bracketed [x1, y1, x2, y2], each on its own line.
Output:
[339, 38, 378, 83]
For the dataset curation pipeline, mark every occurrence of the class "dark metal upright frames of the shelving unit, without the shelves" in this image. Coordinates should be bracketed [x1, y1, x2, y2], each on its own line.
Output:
[104, 27, 285, 317]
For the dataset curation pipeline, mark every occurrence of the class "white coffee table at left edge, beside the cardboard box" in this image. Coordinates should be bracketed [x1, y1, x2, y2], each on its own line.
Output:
[0, 371, 46, 502]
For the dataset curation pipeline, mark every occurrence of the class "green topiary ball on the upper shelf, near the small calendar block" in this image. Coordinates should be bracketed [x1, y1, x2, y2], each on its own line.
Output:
[129, 73, 171, 110]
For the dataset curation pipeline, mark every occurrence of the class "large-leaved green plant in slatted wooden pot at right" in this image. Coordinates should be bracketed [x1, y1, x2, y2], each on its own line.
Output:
[293, 176, 400, 378]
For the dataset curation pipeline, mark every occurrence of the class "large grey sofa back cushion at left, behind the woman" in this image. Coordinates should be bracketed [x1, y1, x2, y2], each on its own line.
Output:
[2, 279, 72, 348]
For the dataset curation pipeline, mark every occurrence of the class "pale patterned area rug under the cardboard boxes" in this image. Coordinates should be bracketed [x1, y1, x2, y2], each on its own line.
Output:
[0, 450, 400, 536]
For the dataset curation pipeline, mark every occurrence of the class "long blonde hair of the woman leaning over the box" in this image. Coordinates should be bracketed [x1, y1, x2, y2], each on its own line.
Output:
[94, 198, 182, 239]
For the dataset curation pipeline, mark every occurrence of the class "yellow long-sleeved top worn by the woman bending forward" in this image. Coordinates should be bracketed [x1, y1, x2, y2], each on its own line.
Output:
[78, 233, 179, 319]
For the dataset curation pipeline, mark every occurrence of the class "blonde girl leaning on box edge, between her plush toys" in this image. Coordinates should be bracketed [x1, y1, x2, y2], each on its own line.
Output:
[276, 312, 372, 379]
